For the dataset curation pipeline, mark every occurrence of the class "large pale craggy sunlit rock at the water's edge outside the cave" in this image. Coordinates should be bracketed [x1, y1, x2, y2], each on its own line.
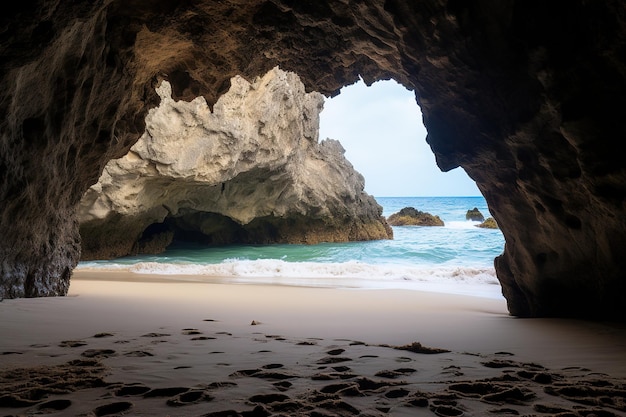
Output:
[78, 68, 392, 259]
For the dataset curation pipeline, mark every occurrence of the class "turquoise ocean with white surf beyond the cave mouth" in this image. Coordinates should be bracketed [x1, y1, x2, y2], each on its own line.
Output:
[77, 197, 504, 298]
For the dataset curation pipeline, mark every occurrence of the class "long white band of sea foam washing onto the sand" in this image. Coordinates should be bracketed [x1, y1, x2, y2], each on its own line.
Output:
[76, 259, 501, 298]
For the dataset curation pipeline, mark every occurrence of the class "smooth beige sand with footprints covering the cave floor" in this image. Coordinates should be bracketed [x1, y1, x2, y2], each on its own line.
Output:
[0, 272, 626, 417]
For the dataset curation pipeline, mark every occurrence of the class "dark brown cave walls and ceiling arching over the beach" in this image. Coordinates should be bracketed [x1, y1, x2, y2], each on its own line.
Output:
[0, 0, 626, 320]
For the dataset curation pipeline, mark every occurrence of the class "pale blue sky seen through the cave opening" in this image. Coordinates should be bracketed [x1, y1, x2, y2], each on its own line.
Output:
[320, 80, 481, 197]
